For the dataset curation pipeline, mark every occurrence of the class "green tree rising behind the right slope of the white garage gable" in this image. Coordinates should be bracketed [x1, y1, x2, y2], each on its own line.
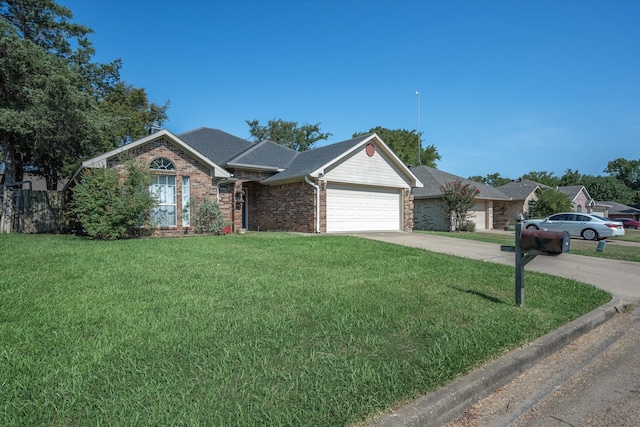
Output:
[353, 126, 440, 168]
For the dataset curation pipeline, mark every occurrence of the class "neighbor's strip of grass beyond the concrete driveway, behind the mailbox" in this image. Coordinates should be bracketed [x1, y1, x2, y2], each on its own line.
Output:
[414, 229, 640, 262]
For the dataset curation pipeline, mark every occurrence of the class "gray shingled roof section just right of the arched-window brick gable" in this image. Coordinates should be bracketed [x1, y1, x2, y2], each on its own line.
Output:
[177, 127, 253, 167]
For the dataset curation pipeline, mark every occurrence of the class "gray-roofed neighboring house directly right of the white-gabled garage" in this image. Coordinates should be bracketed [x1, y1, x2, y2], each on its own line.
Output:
[411, 166, 515, 231]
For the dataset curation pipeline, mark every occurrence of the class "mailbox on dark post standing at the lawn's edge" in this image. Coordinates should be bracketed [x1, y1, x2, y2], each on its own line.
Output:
[500, 214, 571, 307]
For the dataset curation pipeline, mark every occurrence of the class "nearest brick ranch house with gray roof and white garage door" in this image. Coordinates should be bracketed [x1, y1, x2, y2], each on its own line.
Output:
[70, 128, 422, 234]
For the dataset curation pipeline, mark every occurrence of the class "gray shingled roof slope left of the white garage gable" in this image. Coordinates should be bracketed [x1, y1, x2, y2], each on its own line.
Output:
[263, 134, 372, 183]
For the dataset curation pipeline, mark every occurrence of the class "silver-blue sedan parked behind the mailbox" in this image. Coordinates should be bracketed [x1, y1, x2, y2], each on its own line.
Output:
[523, 212, 624, 240]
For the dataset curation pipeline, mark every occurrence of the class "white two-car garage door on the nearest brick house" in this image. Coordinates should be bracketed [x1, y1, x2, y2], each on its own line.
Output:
[327, 184, 402, 232]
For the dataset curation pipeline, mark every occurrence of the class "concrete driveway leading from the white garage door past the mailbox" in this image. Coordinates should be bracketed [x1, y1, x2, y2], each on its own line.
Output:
[352, 232, 640, 304]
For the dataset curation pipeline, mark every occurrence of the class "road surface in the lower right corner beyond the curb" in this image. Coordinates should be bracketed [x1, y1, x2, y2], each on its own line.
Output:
[446, 310, 640, 427]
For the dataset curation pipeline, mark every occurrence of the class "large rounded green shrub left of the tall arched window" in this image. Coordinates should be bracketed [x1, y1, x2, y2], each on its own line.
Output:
[71, 161, 157, 240]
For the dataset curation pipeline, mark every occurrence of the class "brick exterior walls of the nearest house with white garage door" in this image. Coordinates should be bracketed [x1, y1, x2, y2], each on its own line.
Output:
[107, 138, 414, 235]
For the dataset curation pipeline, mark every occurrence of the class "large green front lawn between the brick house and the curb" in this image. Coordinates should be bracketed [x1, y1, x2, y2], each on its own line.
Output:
[0, 233, 609, 426]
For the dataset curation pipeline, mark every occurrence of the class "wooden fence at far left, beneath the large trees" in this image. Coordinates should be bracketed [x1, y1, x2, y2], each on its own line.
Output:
[0, 188, 69, 233]
